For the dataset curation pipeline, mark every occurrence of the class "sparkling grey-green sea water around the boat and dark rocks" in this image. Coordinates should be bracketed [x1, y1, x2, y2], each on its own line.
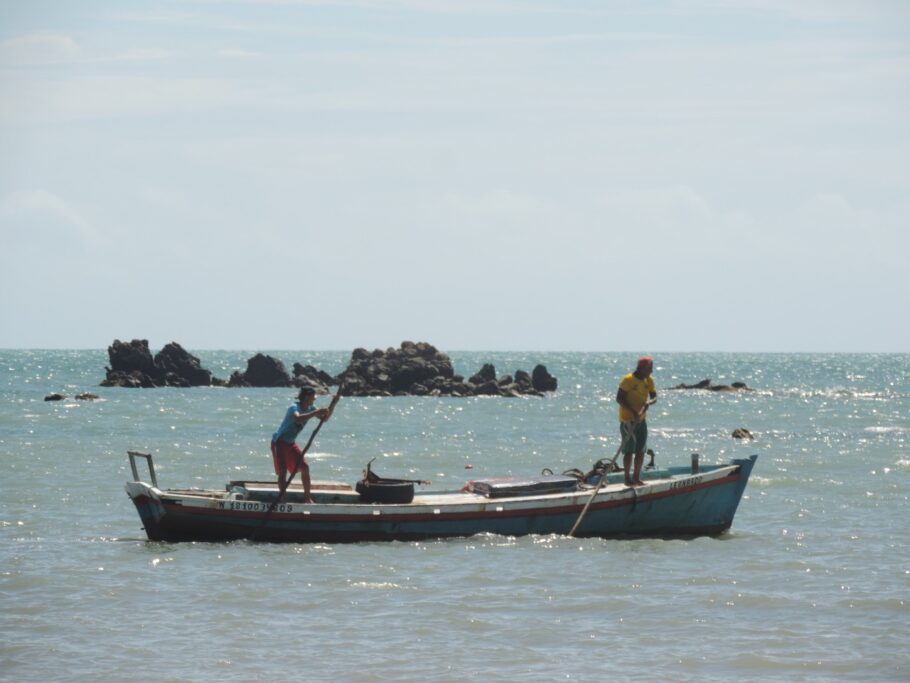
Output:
[0, 349, 910, 682]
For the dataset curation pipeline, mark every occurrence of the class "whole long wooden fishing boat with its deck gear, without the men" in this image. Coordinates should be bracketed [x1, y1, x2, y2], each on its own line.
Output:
[126, 451, 758, 543]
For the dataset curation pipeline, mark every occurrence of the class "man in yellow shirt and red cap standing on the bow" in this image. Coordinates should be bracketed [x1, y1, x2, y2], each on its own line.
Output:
[616, 356, 657, 486]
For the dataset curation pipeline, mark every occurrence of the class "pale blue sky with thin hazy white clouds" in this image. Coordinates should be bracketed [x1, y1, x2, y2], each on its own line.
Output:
[0, 0, 910, 353]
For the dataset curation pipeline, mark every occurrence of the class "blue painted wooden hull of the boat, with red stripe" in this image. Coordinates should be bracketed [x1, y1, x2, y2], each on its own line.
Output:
[126, 456, 757, 543]
